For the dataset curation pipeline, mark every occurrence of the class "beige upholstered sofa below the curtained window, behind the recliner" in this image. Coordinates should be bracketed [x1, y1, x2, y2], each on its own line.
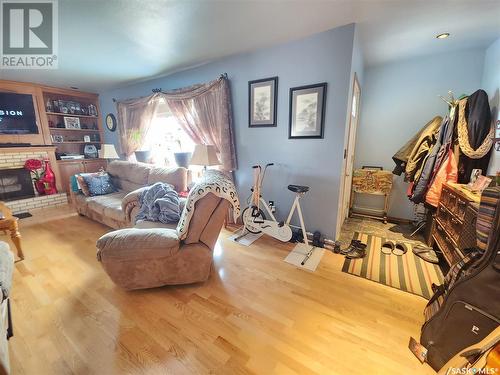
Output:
[72, 161, 188, 229]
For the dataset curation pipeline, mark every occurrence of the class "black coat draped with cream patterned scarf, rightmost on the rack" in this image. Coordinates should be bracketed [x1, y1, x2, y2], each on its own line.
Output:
[457, 90, 493, 184]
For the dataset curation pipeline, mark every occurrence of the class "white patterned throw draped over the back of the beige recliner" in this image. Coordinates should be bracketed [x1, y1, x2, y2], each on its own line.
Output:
[177, 170, 240, 240]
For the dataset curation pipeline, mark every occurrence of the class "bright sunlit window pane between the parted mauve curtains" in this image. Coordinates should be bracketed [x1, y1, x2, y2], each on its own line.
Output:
[143, 106, 195, 167]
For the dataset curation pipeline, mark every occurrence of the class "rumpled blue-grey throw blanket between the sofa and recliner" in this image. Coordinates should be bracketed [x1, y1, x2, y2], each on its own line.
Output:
[135, 182, 180, 224]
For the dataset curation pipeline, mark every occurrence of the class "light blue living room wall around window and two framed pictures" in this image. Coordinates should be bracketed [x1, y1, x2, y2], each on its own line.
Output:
[100, 24, 355, 238]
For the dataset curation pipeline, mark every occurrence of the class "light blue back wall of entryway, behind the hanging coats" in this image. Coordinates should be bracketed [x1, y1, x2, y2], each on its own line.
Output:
[355, 49, 486, 219]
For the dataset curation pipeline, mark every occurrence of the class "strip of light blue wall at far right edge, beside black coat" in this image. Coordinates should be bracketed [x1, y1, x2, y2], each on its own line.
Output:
[482, 39, 500, 175]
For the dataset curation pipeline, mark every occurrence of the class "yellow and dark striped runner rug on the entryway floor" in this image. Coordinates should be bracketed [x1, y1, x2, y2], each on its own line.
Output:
[342, 233, 443, 299]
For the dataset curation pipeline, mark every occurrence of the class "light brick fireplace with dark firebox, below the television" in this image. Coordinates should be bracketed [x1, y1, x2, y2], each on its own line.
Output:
[0, 146, 68, 214]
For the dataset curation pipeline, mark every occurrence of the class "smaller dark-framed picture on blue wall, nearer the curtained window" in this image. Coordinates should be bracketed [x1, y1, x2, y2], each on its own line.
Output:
[248, 77, 278, 128]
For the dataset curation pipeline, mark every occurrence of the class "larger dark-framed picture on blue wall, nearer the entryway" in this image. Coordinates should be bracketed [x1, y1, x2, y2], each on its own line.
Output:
[288, 82, 327, 138]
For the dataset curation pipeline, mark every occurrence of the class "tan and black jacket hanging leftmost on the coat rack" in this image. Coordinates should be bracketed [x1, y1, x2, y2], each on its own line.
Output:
[405, 116, 443, 181]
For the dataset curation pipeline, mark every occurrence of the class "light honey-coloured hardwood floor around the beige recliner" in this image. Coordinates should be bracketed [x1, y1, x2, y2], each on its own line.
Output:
[2, 209, 434, 375]
